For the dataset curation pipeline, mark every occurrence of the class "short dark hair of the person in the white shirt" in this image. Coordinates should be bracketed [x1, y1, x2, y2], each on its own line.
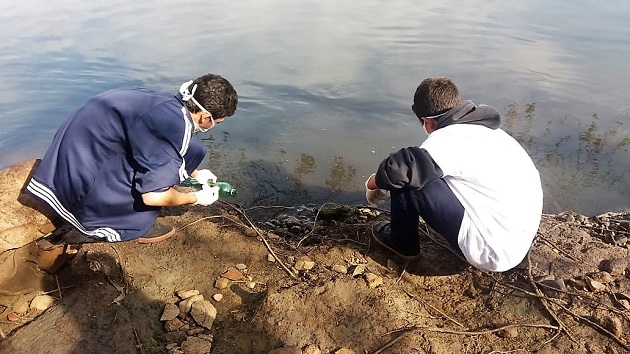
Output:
[411, 77, 462, 118]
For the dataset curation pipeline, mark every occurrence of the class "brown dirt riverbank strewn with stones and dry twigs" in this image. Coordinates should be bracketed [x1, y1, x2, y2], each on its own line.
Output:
[0, 203, 630, 354]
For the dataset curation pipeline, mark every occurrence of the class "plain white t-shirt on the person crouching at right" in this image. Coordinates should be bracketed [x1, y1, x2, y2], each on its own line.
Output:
[420, 124, 543, 272]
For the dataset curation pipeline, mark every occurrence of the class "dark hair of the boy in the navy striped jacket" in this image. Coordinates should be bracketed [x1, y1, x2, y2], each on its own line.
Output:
[186, 74, 238, 118]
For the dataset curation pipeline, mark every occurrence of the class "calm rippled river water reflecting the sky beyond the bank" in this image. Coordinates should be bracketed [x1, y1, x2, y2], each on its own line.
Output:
[0, 0, 630, 215]
